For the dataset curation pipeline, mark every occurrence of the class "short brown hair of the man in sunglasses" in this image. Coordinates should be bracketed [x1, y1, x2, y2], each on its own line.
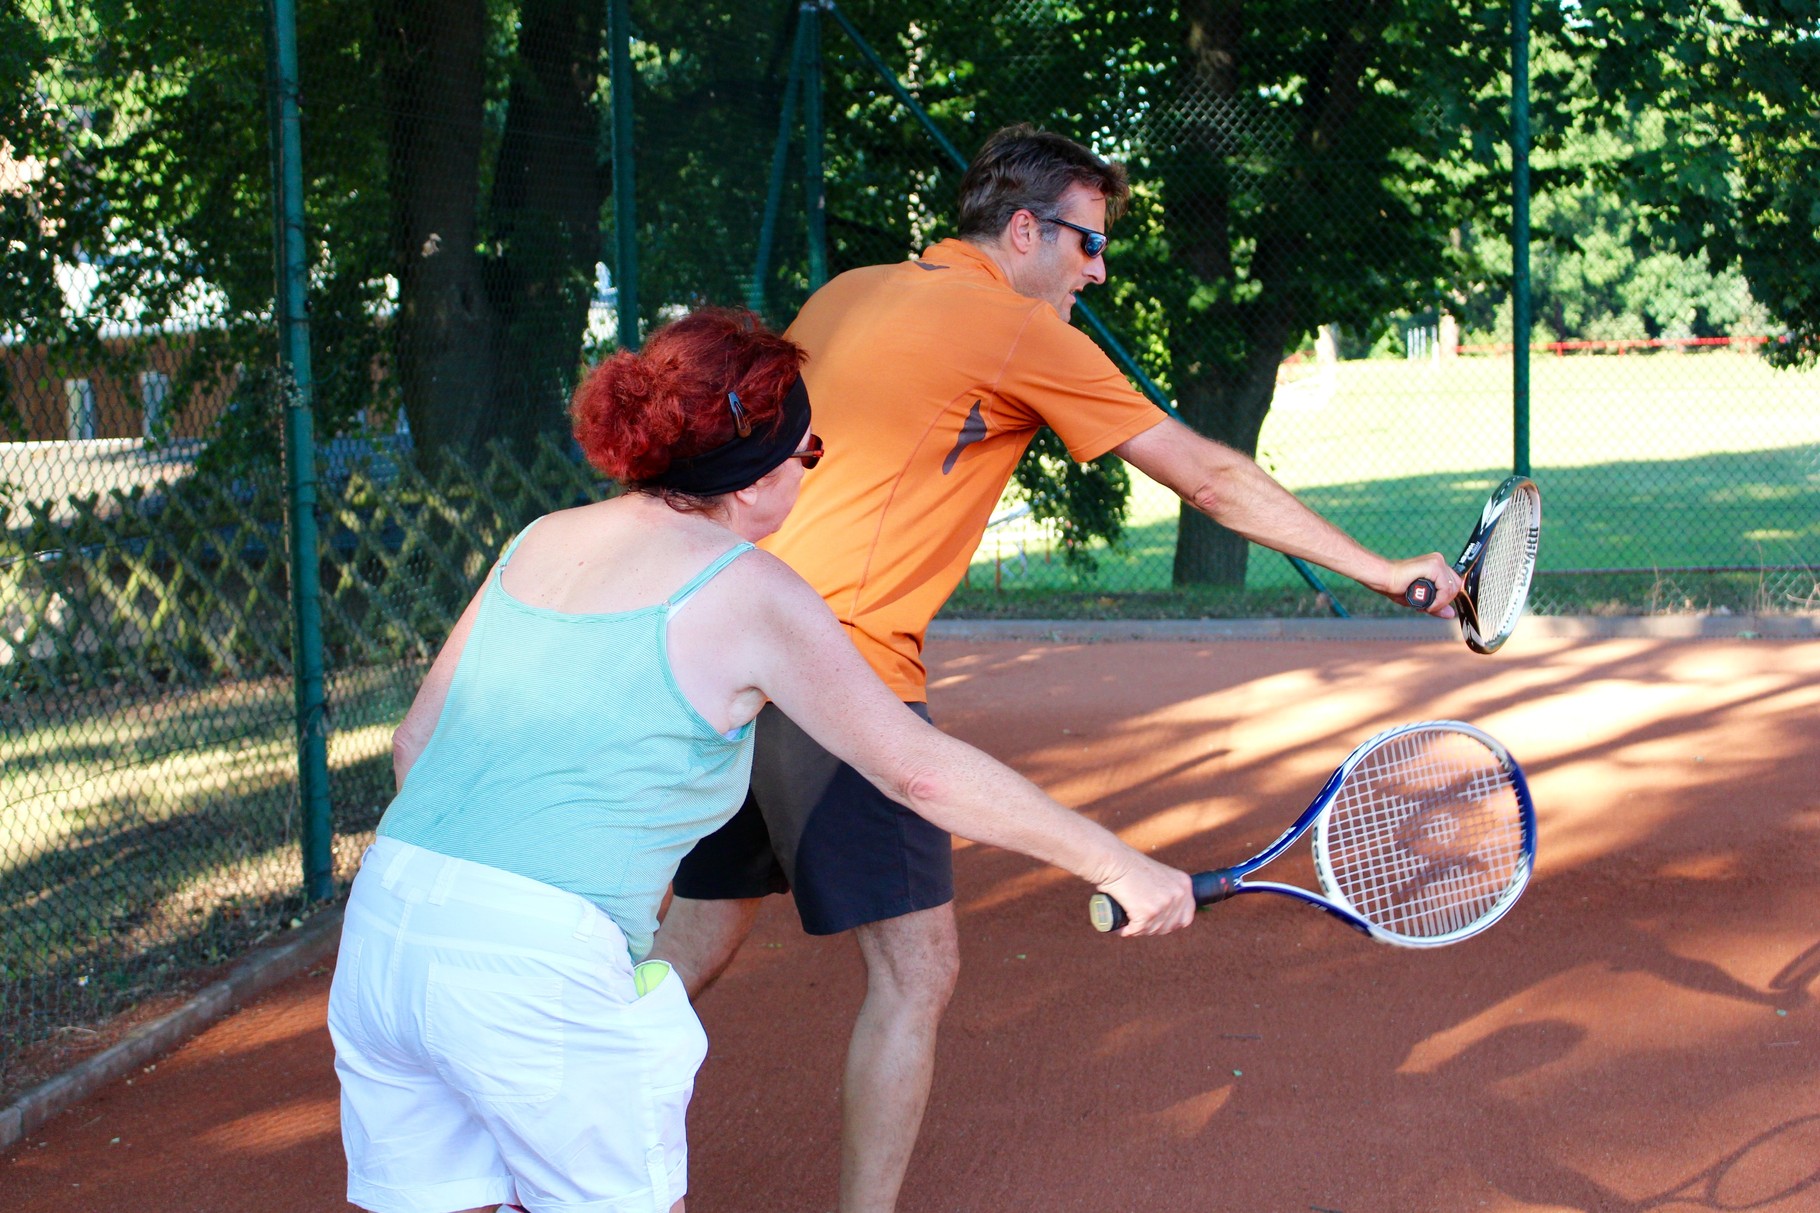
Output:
[959, 122, 1132, 240]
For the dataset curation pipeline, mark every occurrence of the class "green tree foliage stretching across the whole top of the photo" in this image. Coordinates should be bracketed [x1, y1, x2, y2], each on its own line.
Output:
[0, 0, 1820, 583]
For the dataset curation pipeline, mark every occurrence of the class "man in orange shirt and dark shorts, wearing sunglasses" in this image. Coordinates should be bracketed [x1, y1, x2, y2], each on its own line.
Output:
[653, 126, 1460, 1213]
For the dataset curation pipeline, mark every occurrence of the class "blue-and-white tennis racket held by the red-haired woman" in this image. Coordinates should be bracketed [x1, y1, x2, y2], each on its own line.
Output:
[1088, 719, 1536, 947]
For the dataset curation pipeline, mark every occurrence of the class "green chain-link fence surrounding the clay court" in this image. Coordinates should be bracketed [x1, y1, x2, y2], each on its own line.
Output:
[0, 0, 1820, 1089]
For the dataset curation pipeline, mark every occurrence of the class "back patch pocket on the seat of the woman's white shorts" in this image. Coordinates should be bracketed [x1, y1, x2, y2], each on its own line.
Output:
[424, 962, 564, 1104]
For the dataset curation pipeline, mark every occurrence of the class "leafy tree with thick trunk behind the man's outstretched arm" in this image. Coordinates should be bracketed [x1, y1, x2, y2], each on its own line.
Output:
[1141, 0, 1503, 585]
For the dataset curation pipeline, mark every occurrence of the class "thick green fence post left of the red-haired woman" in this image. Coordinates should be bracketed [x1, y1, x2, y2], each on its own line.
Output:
[266, 0, 335, 902]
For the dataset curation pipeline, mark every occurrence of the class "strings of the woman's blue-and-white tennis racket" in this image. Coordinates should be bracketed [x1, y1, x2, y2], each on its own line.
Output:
[1320, 734, 1525, 940]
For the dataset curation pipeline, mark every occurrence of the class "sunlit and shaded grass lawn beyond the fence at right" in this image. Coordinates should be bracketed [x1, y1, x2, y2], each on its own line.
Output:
[950, 352, 1820, 614]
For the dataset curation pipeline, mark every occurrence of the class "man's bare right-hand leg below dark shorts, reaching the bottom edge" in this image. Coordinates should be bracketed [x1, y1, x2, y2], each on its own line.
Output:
[841, 903, 961, 1213]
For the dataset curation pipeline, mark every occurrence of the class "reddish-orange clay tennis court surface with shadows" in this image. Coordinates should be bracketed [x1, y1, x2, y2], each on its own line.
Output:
[0, 623, 1820, 1213]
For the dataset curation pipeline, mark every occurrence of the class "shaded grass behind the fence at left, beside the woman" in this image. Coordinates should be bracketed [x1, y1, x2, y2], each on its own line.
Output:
[0, 663, 422, 1091]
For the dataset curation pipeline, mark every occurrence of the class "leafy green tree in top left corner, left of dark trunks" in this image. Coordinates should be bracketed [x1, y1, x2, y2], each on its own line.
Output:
[0, 0, 396, 466]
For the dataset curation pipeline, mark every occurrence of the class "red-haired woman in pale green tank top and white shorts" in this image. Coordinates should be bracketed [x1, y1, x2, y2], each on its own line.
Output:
[329, 311, 1194, 1213]
